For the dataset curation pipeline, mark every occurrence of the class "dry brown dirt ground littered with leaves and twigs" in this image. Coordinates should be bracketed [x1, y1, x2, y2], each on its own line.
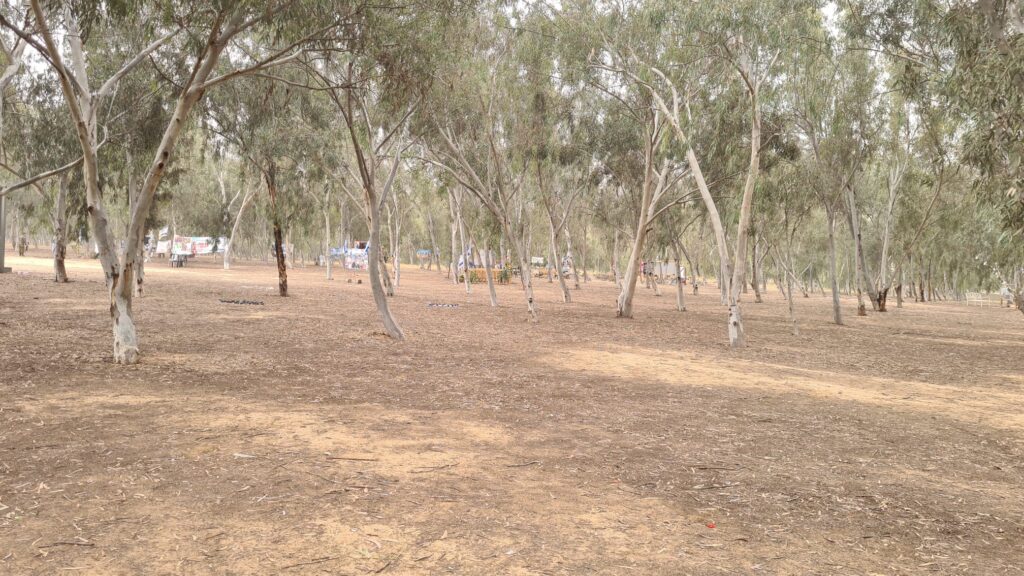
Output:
[0, 249, 1024, 576]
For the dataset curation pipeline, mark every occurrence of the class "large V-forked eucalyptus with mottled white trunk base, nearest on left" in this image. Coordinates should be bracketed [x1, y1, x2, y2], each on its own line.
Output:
[0, 0, 350, 364]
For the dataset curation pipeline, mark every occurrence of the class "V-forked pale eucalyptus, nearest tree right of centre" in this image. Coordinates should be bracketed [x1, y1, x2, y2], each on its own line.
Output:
[604, 0, 817, 347]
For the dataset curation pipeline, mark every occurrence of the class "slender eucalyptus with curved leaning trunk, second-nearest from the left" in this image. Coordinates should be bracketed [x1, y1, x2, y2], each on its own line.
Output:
[307, 0, 468, 340]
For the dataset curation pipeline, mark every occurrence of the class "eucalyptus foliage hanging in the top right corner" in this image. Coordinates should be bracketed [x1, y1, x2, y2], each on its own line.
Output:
[843, 0, 1024, 235]
